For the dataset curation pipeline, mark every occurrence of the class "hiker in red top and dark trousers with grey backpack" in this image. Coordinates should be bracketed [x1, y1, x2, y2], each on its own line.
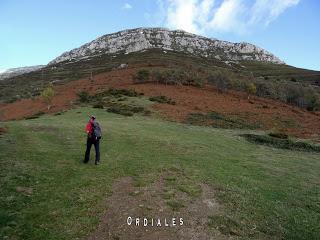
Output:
[84, 116, 101, 165]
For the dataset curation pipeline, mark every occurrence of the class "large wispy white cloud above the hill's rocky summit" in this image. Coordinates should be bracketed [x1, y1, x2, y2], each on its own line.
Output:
[158, 0, 300, 33]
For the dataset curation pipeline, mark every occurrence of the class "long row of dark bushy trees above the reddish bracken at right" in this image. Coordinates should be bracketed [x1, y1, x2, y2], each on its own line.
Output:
[133, 69, 320, 111]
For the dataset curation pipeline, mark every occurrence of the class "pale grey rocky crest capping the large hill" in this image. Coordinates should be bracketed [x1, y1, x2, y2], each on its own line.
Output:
[49, 28, 284, 65]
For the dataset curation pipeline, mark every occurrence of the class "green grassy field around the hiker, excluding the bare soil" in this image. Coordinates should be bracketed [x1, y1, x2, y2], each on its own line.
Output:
[0, 107, 320, 239]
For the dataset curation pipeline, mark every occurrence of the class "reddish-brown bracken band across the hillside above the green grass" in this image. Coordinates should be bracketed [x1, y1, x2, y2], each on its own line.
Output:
[0, 68, 320, 140]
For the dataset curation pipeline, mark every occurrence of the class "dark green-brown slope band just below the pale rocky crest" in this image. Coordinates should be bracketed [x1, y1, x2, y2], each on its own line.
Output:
[0, 49, 320, 105]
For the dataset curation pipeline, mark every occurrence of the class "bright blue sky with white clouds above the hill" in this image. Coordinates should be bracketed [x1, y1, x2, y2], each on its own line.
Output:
[0, 0, 320, 71]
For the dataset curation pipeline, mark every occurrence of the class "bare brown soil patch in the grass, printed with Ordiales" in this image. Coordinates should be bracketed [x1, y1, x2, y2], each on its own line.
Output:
[89, 172, 233, 240]
